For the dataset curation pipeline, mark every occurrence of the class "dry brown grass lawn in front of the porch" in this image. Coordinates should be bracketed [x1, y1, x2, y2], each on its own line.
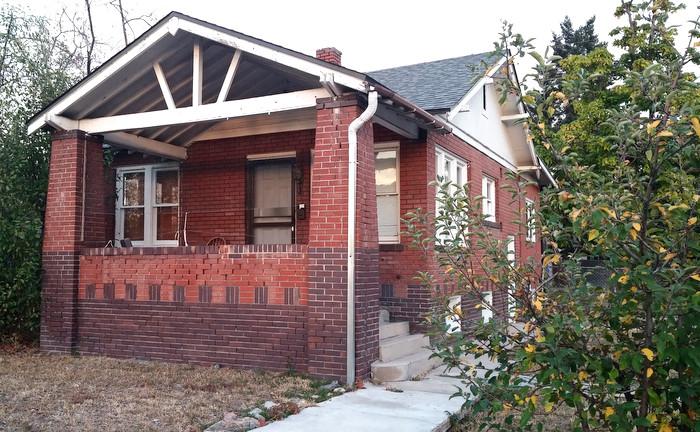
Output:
[0, 350, 318, 431]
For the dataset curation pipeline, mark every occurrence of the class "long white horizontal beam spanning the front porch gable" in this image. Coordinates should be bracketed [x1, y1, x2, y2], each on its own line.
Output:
[43, 89, 329, 134]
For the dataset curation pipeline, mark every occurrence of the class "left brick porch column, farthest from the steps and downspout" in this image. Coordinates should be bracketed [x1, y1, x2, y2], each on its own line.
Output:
[41, 131, 106, 353]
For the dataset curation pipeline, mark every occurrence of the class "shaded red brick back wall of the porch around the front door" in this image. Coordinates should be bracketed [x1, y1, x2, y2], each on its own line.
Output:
[108, 130, 314, 245]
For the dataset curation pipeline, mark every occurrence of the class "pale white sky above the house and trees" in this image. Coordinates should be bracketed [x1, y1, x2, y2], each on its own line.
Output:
[6, 0, 698, 72]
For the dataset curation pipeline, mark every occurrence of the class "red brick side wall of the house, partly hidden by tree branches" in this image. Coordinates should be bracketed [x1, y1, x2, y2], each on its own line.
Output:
[375, 126, 541, 329]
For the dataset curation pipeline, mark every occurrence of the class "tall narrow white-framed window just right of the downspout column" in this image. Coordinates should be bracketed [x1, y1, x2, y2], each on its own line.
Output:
[374, 142, 401, 243]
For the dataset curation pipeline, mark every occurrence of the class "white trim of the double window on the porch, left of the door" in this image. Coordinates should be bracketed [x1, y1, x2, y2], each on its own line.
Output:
[114, 163, 181, 246]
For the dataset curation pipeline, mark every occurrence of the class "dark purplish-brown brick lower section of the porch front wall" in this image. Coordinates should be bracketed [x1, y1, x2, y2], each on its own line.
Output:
[77, 299, 307, 372]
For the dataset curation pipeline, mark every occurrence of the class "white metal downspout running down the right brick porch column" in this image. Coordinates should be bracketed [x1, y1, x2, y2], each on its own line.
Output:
[346, 87, 378, 385]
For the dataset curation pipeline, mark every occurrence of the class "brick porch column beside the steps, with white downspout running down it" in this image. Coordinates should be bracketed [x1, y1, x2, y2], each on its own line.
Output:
[308, 95, 379, 380]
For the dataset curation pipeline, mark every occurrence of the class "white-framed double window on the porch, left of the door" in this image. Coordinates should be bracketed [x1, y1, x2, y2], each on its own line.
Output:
[115, 164, 180, 246]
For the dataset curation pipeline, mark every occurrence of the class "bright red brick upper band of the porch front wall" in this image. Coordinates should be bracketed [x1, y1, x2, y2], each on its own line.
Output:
[79, 245, 308, 305]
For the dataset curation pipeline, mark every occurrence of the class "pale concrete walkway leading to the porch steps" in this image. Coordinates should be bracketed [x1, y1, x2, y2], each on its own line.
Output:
[255, 377, 462, 432]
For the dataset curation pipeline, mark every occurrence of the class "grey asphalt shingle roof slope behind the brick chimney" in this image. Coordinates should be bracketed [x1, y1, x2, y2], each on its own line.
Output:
[367, 52, 497, 111]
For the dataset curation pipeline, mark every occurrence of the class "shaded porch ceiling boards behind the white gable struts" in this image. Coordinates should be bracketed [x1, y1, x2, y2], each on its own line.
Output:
[63, 32, 320, 145]
